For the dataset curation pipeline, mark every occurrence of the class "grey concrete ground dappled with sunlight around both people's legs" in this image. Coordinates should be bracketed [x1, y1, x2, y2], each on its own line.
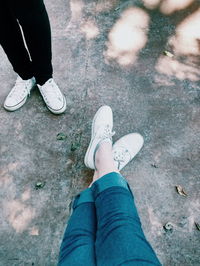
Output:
[0, 0, 200, 266]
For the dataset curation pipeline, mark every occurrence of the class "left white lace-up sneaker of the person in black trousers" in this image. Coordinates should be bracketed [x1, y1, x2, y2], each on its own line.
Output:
[4, 76, 36, 111]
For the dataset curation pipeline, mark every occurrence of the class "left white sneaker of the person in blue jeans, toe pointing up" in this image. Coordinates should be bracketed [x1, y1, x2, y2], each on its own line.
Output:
[84, 105, 115, 169]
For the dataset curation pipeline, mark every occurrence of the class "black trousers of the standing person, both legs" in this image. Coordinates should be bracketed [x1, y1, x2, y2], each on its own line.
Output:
[0, 0, 53, 85]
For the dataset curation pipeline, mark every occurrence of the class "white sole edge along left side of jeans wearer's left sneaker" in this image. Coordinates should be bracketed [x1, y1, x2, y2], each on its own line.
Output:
[84, 105, 112, 169]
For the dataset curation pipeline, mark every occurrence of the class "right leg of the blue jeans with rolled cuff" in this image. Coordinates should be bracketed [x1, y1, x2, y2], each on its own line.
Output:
[91, 172, 161, 266]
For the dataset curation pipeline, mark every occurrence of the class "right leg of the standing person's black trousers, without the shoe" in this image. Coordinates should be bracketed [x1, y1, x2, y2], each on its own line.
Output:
[13, 0, 53, 85]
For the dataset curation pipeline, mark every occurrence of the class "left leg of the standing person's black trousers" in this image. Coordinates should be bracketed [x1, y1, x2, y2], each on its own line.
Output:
[0, 1, 33, 80]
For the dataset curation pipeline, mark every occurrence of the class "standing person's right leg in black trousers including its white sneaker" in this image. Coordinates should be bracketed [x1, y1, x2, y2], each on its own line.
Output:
[12, 0, 67, 114]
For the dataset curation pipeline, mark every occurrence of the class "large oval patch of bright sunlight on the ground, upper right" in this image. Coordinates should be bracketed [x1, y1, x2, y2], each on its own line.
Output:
[104, 7, 149, 66]
